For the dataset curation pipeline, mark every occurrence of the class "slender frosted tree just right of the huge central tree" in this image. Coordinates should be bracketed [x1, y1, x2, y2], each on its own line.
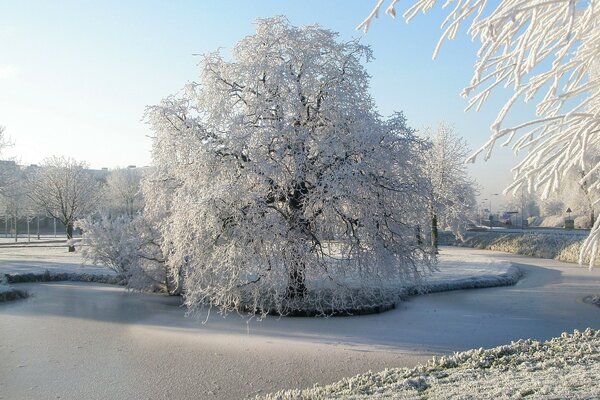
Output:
[422, 123, 477, 247]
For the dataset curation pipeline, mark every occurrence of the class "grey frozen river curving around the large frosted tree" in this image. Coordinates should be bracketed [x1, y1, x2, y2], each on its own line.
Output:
[0, 248, 600, 399]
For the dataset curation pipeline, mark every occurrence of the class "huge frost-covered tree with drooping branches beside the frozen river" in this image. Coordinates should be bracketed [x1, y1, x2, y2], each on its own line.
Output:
[145, 18, 430, 314]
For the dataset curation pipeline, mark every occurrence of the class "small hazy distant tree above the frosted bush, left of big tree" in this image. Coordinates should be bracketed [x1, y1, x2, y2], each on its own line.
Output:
[105, 168, 142, 219]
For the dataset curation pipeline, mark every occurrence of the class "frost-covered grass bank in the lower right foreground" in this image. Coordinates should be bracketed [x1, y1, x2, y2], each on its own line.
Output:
[264, 328, 600, 400]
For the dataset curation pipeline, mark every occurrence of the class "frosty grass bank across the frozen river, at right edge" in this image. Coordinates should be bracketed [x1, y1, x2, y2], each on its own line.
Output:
[460, 232, 600, 265]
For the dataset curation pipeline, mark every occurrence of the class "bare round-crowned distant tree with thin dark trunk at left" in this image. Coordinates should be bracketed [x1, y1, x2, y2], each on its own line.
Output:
[28, 157, 101, 252]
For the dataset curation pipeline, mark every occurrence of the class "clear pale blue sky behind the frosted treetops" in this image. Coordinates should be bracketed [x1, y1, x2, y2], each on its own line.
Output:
[0, 0, 526, 206]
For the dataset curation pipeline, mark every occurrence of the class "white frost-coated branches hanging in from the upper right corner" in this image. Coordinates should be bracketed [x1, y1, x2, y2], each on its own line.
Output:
[359, 0, 600, 267]
